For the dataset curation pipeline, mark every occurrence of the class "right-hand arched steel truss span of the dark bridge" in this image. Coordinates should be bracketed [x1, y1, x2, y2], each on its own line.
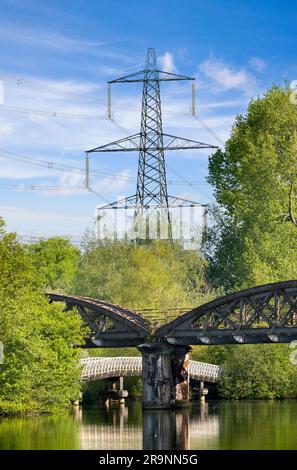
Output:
[157, 280, 297, 345]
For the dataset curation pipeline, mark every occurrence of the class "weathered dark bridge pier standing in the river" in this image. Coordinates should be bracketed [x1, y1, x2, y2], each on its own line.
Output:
[138, 343, 190, 409]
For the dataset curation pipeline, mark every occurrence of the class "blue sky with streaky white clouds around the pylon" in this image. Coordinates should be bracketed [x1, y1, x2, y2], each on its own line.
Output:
[0, 0, 297, 240]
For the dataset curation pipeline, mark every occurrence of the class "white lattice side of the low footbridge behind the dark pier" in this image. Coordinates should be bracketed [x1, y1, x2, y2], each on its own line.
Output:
[81, 357, 221, 383]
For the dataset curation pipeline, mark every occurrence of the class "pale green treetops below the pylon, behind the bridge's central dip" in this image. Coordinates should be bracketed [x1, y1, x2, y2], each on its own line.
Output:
[73, 240, 213, 316]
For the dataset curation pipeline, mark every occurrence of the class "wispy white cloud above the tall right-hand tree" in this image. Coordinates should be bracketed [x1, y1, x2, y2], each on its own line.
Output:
[199, 57, 256, 94]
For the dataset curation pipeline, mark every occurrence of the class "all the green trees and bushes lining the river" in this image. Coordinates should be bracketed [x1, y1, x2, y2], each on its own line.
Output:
[0, 86, 297, 414]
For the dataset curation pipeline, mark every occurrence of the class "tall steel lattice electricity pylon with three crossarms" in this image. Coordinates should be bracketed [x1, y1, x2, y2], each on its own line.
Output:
[86, 48, 217, 238]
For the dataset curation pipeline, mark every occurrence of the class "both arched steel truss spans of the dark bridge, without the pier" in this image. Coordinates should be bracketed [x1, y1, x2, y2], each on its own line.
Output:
[48, 280, 297, 347]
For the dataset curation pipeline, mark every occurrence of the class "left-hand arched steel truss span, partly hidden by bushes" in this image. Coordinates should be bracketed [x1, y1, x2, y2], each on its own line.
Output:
[47, 294, 149, 348]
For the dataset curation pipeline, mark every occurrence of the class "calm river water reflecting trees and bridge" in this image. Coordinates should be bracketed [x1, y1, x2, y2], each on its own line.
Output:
[0, 401, 297, 450]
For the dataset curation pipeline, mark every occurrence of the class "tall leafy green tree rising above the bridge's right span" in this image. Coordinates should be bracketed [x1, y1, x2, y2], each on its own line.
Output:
[206, 87, 297, 291]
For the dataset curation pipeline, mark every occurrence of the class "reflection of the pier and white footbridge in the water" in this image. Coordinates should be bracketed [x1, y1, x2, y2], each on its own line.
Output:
[74, 403, 220, 450]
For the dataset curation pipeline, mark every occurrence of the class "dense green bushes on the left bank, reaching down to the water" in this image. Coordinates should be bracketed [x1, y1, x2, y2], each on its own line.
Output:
[0, 218, 85, 414]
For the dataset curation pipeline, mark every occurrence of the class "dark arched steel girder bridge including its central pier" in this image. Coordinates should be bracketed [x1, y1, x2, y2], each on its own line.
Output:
[48, 280, 297, 408]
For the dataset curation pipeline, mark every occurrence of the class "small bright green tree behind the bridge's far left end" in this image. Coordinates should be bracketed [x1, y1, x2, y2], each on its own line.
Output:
[28, 237, 79, 291]
